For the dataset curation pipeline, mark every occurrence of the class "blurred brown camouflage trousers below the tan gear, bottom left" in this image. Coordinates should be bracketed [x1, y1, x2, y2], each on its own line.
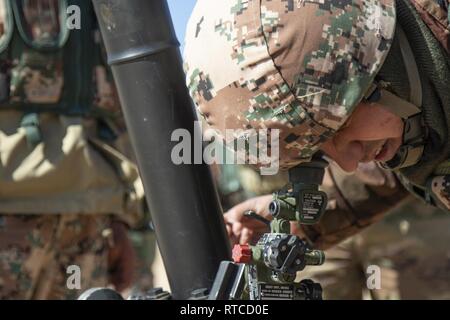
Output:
[0, 214, 109, 299]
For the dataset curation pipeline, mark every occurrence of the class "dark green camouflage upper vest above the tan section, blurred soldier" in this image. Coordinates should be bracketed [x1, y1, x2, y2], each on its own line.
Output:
[0, 0, 120, 140]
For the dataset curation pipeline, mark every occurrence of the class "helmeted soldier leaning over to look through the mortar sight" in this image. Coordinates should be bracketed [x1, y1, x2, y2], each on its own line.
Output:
[185, 0, 450, 298]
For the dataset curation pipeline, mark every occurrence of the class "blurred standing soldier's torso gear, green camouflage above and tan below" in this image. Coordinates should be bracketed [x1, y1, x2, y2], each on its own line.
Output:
[0, 0, 145, 224]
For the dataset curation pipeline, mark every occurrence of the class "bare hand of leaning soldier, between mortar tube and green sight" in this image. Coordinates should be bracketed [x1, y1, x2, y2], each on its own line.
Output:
[224, 195, 272, 245]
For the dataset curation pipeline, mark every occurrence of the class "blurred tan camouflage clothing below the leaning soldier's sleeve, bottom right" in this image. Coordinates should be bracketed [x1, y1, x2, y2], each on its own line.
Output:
[300, 198, 450, 300]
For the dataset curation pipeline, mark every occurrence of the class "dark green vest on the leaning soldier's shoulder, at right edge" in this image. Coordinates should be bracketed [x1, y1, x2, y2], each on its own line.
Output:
[378, 0, 450, 211]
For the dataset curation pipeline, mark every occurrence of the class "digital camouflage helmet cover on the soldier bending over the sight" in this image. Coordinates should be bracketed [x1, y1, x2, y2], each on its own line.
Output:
[185, 0, 395, 168]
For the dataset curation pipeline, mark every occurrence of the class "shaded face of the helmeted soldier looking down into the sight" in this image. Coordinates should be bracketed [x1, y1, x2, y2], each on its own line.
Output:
[322, 103, 403, 172]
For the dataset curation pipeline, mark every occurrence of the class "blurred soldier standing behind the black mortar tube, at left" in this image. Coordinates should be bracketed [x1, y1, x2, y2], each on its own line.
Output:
[0, 0, 143, 299]
